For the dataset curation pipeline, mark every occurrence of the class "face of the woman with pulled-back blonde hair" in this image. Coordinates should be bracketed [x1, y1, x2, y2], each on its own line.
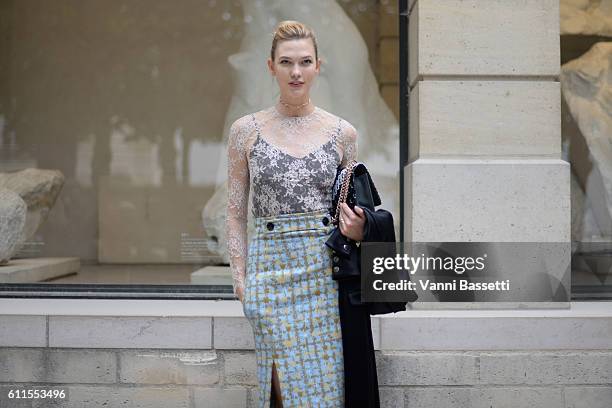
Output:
[268, 38, 321, 103]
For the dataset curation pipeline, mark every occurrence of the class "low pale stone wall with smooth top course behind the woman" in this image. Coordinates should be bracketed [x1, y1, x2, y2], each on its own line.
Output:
[0, 301, 612, 408]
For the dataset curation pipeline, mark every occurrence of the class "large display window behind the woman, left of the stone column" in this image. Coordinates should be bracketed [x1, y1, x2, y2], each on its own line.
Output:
[0, 0, 399, 291]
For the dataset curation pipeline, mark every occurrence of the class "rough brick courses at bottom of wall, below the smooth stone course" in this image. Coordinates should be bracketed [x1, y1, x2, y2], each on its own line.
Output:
[0, 348, 612, 408]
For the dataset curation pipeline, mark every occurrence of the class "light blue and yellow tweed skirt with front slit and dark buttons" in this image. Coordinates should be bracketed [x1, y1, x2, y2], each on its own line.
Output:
[243, 210, 344, 408]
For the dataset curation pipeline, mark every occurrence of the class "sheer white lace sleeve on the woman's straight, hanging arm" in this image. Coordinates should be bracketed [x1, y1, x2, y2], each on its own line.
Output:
[226, 119, 249, 293]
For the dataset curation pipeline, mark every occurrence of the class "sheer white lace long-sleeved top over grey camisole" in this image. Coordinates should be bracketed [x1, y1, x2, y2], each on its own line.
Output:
[226, 106, 357, 292]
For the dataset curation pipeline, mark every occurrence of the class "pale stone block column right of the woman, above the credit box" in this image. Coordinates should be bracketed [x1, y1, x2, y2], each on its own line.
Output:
[404, 0, 570, 307]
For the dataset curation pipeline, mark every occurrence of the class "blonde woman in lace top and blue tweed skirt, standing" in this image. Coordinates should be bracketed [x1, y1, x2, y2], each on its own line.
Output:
[227, 21, 365, 408]
